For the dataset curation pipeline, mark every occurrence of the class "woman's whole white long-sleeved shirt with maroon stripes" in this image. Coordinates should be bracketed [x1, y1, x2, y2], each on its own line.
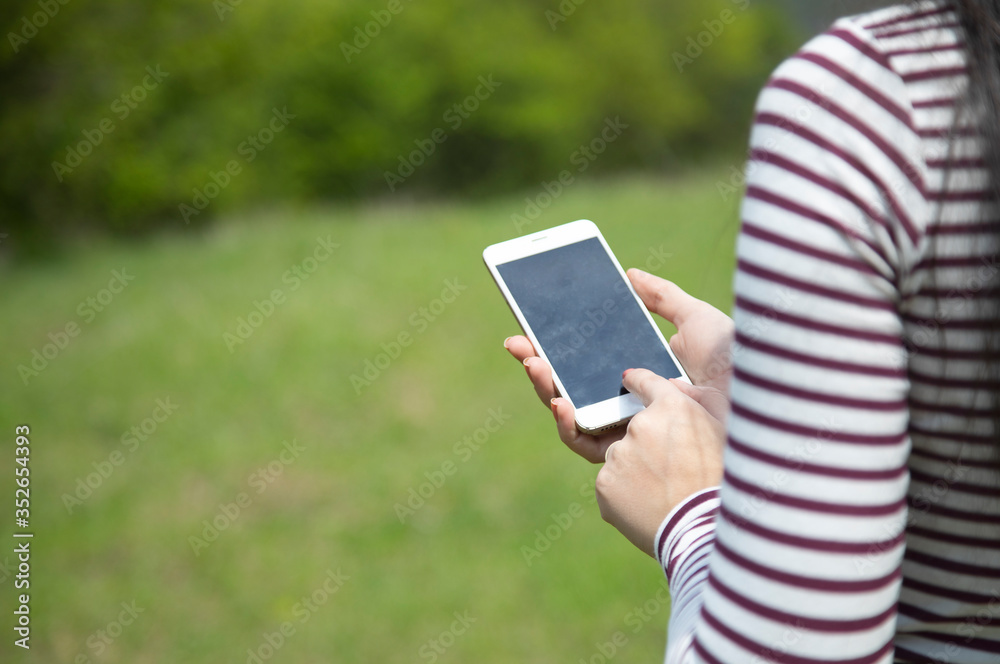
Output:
[657, 1, 1000, 664]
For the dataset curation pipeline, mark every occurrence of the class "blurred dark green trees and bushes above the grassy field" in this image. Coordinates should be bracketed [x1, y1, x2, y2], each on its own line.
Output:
[0, 0, 798, 243]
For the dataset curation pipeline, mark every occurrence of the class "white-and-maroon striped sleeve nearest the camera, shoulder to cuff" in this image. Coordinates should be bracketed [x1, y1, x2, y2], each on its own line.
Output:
[657, 10, 940, 664]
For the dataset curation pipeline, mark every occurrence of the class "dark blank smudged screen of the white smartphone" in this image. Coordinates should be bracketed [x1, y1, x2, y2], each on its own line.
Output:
[497, 238, 681, 408]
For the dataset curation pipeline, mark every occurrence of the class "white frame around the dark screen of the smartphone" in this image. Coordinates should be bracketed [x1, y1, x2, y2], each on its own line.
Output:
[483, 219, 691, 434]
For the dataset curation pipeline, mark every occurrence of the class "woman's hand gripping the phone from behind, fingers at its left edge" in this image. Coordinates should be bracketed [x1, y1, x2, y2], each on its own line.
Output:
[504, 269, 734, 463]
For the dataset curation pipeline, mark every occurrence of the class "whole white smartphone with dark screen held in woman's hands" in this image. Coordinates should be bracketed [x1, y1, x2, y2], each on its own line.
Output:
[483, 220, 690, 434]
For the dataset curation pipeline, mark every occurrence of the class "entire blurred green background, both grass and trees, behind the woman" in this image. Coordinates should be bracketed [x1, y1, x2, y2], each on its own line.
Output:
[0, 0, 876, 664]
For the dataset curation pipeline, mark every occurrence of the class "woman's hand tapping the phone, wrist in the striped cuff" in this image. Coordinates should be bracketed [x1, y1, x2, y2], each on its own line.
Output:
[597, 369, 726, 557]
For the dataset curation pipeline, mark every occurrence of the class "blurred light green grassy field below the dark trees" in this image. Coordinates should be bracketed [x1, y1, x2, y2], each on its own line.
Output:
[0, 167, 737, 664]
